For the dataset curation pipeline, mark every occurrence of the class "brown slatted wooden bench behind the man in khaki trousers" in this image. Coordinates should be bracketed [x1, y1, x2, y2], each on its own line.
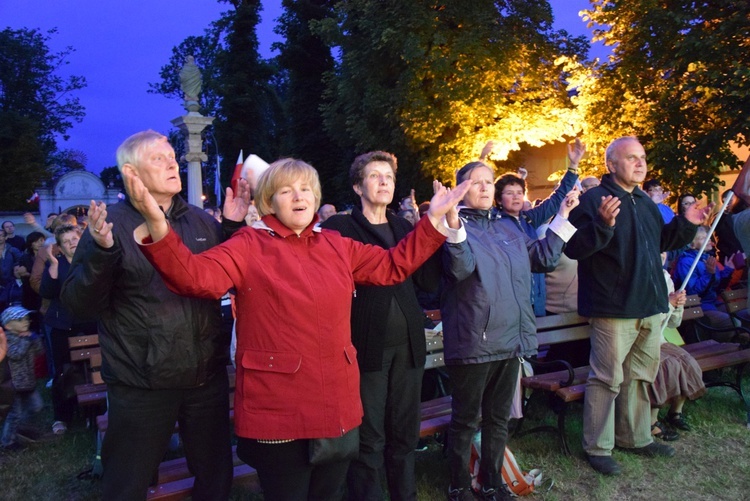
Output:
[516, 296, 750, 454]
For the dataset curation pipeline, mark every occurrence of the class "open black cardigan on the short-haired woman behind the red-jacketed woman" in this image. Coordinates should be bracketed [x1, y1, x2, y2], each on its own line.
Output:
[321, 207, 440, 372]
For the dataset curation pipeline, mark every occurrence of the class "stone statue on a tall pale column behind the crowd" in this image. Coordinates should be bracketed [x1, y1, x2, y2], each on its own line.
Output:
[172, 56, 214, 208]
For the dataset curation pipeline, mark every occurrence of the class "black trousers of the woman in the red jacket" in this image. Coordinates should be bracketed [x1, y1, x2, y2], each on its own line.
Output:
[237, 437, 349, 501]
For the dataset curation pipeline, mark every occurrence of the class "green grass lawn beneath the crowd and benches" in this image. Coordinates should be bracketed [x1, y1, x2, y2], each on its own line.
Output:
[0, 376, 750, 501]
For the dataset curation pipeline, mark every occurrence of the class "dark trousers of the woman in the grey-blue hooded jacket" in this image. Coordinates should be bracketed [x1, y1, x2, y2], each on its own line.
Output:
[446, 358, 520, 488]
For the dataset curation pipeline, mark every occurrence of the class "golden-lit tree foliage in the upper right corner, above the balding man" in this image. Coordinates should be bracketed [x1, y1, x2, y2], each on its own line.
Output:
[577, 0, 750, 193]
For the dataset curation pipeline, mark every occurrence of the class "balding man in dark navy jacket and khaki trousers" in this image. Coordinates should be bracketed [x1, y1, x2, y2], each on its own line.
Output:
[565, 136, 705, 475]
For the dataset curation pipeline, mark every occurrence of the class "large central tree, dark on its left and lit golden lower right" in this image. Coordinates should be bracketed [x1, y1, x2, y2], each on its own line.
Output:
[316, 0, 587, 193]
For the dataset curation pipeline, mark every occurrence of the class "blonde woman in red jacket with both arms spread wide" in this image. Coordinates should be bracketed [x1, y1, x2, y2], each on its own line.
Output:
[104, 159, 469, 500]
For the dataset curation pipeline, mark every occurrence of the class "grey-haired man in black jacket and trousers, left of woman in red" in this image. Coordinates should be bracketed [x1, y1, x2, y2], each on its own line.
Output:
[61, 130, 249, 500]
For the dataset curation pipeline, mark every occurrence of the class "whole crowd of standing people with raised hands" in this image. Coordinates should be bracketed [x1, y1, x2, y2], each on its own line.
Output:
[0, 131, 750, 500]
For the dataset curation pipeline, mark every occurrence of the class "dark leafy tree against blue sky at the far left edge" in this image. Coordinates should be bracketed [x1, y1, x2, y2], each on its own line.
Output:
[0, 28, 86, 210]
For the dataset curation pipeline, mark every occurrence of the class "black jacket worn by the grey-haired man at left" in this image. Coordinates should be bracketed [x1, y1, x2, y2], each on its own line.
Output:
[60, 196, 229, 389]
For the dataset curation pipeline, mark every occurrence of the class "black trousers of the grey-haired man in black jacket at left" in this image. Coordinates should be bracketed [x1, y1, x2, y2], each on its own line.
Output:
[102, 369, 233, 501]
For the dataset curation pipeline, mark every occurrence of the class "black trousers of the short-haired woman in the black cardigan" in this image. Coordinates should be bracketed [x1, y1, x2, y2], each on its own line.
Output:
[347, 343, 424, 501]
